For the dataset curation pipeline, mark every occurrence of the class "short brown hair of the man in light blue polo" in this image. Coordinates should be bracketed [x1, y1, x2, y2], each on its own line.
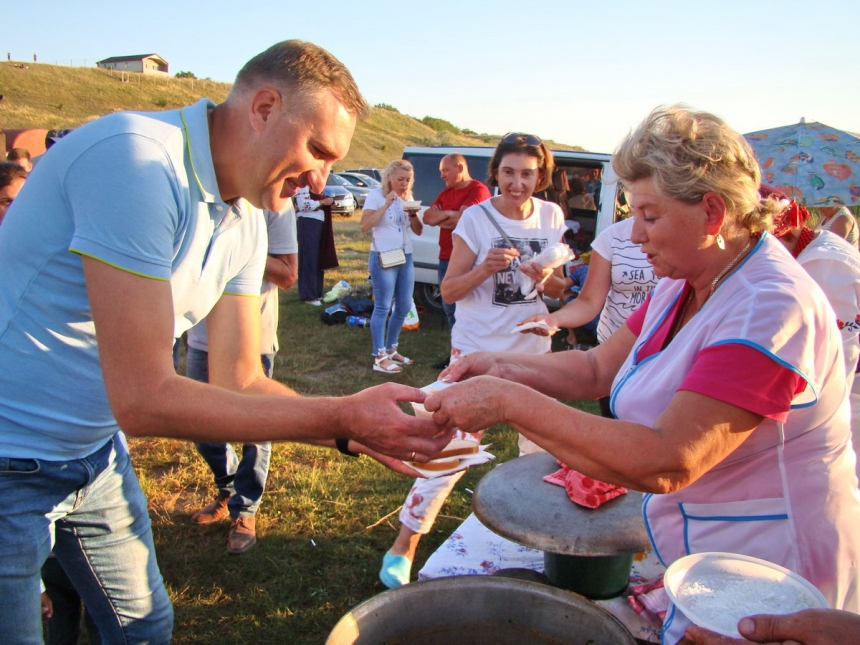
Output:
[235, 40, 370, 118]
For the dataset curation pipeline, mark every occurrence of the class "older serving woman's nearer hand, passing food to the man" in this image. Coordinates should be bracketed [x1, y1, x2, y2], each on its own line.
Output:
[424, 376, 521, 432]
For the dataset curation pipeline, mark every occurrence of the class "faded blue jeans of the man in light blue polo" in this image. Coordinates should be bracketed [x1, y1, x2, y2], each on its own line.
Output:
[0, 439, 173, 645]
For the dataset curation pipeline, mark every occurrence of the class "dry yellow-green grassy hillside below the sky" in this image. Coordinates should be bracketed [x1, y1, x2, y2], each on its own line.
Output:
[0, 62, 581, 169]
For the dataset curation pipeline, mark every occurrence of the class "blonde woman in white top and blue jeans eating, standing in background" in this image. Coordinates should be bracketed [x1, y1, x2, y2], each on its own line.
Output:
[361, 159, 424, 374]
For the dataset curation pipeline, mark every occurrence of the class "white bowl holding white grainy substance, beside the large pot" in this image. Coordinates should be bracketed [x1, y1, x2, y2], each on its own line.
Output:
[663, 552, 829, 638]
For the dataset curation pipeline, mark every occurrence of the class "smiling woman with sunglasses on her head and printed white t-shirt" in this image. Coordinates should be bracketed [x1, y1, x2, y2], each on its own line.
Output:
[379, 133, 566, 588]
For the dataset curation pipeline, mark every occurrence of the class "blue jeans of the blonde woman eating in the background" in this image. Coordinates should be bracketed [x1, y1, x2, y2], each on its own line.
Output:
[367, 251, 415, 356]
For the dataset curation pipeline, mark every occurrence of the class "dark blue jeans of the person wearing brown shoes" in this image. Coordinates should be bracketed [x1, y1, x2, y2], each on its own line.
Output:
[185, 347, 275, 519]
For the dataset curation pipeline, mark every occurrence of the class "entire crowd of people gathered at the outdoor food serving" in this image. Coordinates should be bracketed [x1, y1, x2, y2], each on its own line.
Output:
[0, 41, 860, 645]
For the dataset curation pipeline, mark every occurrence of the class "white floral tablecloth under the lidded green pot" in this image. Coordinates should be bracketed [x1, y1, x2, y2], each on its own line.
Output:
[418, 514, 665, 643]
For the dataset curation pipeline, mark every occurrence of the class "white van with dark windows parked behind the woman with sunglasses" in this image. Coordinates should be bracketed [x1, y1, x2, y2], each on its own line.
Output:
[403, 146, 618, 311]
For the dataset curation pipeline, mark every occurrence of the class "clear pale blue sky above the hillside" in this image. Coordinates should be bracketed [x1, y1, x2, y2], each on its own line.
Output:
[0, 0, 860, 152]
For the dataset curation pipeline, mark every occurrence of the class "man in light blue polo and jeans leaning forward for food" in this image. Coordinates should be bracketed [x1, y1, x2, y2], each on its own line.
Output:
[0, 41, 450, 644]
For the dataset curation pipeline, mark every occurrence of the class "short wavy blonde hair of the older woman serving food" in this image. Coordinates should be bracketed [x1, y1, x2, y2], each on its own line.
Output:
[612, 105, 779, 233]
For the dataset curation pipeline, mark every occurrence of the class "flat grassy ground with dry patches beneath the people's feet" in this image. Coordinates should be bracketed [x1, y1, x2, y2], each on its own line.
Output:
[131, 210, 591, 644]
